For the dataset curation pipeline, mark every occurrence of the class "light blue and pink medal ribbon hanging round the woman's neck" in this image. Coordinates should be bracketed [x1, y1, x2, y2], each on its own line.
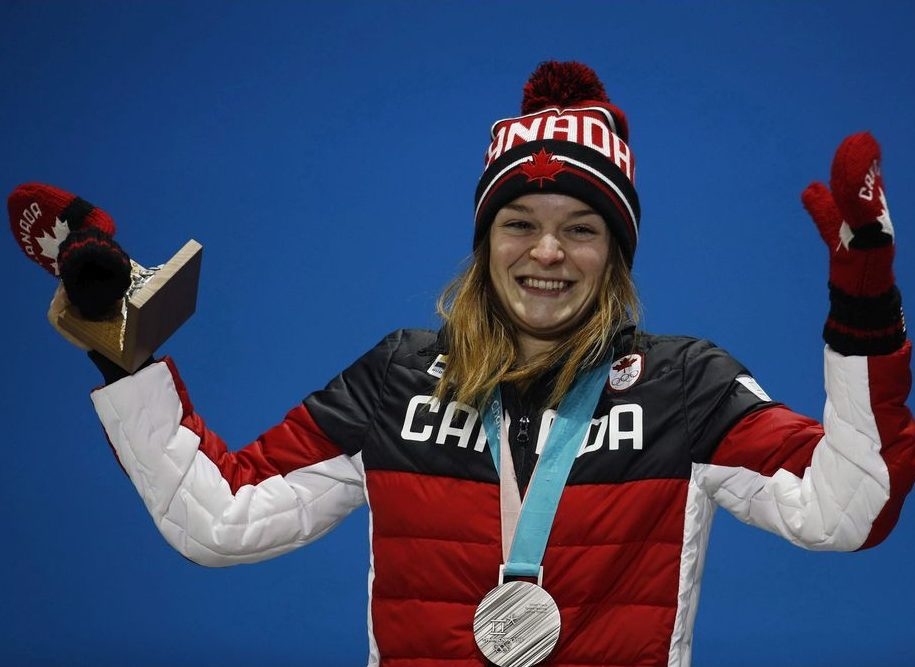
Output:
[483, 355, 612, 577]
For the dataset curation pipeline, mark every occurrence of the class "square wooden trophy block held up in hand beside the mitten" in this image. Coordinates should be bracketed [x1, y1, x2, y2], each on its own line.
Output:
[54, 239, 203, 373]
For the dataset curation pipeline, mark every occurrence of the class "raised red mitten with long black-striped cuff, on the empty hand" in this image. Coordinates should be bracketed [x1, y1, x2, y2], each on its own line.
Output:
[801, 132, 905, 355]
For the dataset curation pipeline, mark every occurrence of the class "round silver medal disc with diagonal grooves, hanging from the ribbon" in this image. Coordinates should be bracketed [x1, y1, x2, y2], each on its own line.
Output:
[473, 581, 560, 667]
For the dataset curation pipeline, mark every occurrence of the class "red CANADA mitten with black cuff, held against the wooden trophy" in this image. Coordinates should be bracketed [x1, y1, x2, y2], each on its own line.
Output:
[7, 183, 130, 320]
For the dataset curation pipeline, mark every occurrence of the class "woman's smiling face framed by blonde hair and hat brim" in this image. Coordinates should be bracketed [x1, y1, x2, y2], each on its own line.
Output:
[489, 194, 610, 347]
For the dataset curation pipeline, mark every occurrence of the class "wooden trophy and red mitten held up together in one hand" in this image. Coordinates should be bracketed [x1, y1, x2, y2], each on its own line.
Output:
[7, 183, 203, 373]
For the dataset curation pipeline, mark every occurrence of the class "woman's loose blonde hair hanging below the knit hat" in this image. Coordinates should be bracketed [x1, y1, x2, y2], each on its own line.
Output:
[435, 237, 639, 408]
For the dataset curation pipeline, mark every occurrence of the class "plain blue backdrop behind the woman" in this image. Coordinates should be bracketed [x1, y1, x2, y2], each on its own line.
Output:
[0, 0, 915, 667]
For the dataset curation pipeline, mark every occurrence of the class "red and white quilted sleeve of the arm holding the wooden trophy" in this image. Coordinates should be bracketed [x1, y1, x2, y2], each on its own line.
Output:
[92, 336, 400, 566]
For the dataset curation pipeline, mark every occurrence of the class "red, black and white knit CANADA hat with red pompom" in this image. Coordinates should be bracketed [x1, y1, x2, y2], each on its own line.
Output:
[473, 61, 641, 267]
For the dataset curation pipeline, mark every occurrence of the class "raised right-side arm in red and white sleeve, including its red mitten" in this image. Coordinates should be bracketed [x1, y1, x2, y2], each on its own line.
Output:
[698, 133, 915, 550]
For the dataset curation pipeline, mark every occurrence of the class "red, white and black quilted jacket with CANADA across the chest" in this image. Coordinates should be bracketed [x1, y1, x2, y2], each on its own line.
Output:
[92, 330, 915, 667]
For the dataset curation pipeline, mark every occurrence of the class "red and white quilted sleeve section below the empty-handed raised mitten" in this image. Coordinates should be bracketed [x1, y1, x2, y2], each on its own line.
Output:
[694, 342, 915, 551]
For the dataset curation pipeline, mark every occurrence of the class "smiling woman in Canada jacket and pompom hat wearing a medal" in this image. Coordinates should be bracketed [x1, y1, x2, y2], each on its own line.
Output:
[23, 63, 915, 666]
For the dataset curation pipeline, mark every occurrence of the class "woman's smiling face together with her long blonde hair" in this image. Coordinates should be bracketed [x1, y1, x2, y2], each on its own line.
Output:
[436, 188, 638, 404]
